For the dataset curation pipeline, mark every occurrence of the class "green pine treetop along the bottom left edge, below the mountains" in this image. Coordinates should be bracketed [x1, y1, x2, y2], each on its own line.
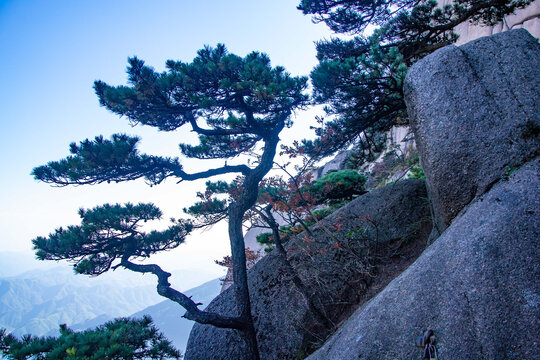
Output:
[0, 316, 181, 360]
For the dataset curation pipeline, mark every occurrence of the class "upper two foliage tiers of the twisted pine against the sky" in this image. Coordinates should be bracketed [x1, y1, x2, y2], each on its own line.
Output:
[32, 45, 308, 186]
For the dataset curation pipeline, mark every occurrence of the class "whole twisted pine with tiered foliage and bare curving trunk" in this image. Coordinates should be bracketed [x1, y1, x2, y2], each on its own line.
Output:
[33, 45, 308, 359]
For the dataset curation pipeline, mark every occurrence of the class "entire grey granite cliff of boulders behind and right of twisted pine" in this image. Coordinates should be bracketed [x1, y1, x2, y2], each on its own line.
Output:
[186, 30, 540, 360]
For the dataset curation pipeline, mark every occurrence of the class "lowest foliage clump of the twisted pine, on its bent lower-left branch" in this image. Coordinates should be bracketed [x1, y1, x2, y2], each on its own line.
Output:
[32, 203, 192, 275]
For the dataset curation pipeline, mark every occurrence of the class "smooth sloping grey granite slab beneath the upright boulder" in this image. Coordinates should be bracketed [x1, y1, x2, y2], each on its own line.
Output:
[308, 160, 540, 360]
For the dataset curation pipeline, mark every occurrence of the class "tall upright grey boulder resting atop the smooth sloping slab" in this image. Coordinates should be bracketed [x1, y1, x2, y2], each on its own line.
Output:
[404, 29, 540, 233]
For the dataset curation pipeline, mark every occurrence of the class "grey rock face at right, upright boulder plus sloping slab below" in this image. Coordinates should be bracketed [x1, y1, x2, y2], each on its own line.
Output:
[308, 30, 540, 360]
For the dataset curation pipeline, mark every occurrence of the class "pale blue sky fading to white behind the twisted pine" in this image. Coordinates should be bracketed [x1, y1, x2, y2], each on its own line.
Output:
[0, 0, 330, 282]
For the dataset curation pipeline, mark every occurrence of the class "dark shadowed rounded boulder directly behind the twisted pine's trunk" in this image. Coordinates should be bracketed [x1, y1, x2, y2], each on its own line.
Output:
[185, 180, 431, 360]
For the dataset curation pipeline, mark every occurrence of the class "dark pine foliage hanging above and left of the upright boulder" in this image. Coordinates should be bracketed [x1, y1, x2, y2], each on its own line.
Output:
[298, 0, 531, 155]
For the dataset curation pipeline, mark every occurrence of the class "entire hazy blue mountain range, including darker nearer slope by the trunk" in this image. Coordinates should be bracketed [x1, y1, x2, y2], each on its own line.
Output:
[0, 253, 221, 351]
